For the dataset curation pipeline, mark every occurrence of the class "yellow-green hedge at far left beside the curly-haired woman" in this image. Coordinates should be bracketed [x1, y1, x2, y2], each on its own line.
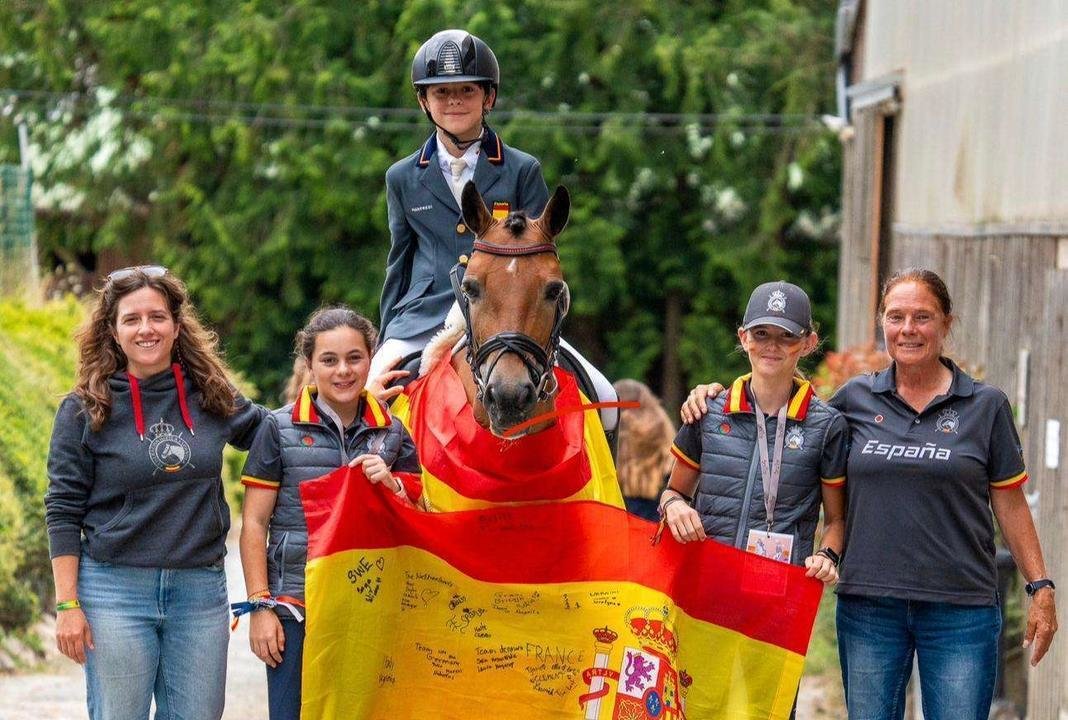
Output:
[0, 299, 84, 631]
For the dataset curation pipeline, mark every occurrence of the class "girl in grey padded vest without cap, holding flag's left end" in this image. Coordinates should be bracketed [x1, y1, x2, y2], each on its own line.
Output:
[241, 307, 420, 720]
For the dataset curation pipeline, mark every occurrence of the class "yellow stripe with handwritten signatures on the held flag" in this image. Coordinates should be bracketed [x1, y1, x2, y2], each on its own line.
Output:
[301, 547, 804, 720]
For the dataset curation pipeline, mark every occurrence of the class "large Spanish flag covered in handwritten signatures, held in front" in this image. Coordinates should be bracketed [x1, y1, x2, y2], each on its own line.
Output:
[300, 468, 822, 720]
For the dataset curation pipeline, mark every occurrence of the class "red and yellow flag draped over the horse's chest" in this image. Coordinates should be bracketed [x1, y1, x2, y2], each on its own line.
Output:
[392, 358, 623, 512]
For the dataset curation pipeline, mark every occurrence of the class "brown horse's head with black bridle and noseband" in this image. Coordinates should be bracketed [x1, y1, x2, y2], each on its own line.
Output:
[456, 183, 570, 436]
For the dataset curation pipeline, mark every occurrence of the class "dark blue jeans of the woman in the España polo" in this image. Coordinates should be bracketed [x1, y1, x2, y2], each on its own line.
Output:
[837, 595, 1002, 720]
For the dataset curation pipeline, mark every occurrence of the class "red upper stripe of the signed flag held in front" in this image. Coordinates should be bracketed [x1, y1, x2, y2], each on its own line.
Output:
[300, 468, 822, 655]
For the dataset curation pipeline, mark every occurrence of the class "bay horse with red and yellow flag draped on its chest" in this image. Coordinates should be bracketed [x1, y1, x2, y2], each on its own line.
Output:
[393, 183, 623, 510]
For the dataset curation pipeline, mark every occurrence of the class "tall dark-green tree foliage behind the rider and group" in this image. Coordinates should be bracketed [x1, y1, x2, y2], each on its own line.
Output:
[0, 0, 839, 405]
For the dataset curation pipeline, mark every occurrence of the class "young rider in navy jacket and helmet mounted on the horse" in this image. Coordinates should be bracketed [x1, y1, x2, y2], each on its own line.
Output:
[371, 30, 617, 431]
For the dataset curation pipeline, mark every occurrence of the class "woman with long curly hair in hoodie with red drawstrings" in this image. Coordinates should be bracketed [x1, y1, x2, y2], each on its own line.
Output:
[45, 266, 266, 720]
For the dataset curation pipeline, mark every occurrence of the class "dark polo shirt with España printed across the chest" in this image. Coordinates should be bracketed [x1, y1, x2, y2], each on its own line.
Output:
[831, 358, 1027, 605]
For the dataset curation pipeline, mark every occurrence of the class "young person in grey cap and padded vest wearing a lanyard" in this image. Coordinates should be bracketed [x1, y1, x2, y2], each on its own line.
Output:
[660, 282, 848, 583]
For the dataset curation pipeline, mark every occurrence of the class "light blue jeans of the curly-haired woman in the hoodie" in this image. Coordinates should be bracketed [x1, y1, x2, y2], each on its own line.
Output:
[78, 552, 230, 720]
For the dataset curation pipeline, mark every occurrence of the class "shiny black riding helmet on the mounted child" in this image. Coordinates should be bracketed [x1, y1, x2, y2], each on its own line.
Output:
[411, 30, 501, 107]
